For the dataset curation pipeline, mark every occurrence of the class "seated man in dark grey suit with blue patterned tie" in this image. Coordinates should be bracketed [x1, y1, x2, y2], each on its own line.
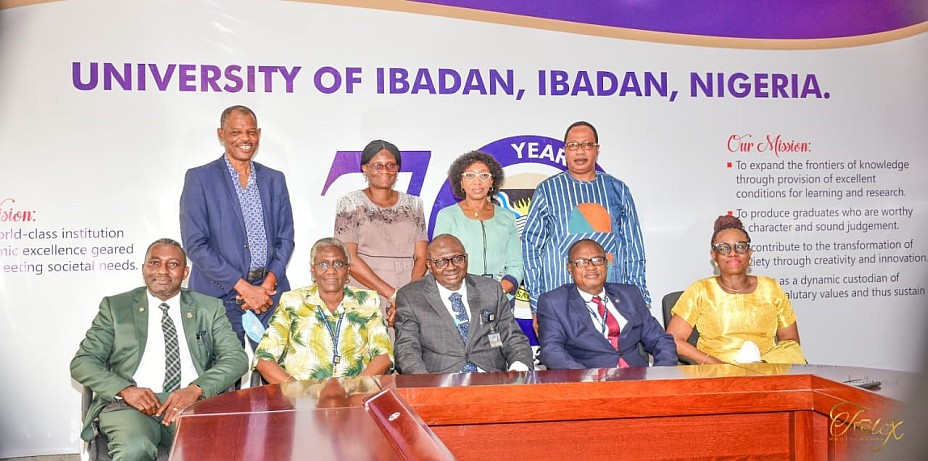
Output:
[394, 234, 532, 374]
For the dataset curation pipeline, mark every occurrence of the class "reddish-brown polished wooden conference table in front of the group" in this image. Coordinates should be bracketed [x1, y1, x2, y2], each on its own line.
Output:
[171, 364, 918, 460]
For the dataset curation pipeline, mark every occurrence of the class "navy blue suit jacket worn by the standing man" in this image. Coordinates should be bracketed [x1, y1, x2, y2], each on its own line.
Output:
[180, 154, 294, 310]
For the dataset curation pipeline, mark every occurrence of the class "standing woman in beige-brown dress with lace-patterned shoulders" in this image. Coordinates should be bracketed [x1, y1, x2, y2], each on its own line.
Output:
[335, 139, 428, 325]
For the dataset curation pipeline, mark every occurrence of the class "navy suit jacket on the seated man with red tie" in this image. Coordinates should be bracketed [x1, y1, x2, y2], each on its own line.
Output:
[538, 283, 677, 369]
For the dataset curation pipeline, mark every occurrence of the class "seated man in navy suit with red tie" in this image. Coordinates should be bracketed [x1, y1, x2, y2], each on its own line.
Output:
[538, 239, 677, 369]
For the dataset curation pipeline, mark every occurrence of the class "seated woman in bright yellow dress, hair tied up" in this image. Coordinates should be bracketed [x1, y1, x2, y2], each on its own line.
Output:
[667, 216, 806, 364]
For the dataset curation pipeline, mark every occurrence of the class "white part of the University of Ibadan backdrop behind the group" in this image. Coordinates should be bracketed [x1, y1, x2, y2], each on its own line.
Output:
[0, 0, 928, 457]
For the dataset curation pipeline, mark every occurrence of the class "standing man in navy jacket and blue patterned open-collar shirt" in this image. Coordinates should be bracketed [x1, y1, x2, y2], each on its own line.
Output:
[180, 106, 294, 345]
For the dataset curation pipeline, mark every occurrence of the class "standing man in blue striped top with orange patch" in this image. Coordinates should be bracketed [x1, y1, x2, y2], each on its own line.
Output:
[522, 121, 651, 330]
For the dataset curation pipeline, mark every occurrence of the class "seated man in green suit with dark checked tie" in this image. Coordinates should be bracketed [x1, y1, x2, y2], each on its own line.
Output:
[71, 239, 248, 460]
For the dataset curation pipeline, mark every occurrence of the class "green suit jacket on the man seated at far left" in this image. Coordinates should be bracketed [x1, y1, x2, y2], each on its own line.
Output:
[71, 287, 248, 441]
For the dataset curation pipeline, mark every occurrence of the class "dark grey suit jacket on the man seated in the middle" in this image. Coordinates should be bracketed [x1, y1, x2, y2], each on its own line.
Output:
[394, 274, 532, 374]
